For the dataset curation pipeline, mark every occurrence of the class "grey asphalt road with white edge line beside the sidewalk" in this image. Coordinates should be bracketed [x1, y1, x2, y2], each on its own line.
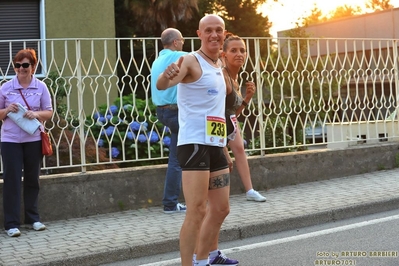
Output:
[104, 210, 399, 266]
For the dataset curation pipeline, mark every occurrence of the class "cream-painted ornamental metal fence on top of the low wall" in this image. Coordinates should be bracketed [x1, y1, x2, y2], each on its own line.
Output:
[0, 38, 399, 173]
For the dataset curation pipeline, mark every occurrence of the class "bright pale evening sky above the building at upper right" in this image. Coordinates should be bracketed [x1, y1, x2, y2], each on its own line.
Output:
[260, 0, 399, 37]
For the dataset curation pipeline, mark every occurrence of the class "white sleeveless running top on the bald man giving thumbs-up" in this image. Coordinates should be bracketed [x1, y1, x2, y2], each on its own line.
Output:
[177, 52, 226, 147]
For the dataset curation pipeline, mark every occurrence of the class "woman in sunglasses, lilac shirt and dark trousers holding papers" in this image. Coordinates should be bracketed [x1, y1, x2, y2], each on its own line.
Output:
[0, 49, 53, 237]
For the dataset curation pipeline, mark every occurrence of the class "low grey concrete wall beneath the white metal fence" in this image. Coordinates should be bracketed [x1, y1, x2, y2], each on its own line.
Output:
[0, 143, 399, 226]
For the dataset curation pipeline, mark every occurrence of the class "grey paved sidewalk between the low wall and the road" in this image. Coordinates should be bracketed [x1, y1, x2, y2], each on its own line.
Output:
[0, 169, 399, 266]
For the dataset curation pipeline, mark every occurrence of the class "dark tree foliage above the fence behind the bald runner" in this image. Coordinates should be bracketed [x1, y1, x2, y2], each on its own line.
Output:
[115, 0, 277, 37]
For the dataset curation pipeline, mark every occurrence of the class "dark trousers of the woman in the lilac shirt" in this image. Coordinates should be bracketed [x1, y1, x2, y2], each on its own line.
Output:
[1, 141, 43, 230]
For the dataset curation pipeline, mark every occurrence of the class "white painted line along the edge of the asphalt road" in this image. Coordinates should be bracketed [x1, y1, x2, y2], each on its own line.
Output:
[140, 215, 399, 266]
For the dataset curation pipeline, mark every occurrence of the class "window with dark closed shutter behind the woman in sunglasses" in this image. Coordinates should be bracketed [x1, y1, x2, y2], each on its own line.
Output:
[0, 0, 44, 79]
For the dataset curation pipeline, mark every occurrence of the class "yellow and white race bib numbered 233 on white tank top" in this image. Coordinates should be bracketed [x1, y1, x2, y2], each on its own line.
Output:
[205, 115, 227, 147]
